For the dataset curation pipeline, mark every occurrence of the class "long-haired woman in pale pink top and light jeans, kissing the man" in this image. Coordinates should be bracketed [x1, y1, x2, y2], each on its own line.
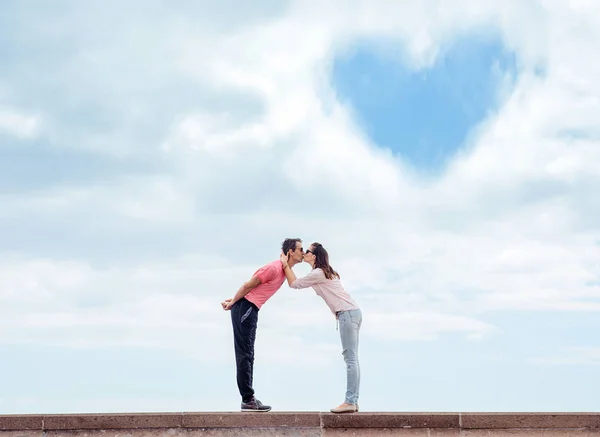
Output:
[281, 243, 362, 413]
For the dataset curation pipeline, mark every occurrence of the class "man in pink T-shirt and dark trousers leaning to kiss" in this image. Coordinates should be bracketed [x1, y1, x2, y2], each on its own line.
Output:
[221, 238, 304, 412]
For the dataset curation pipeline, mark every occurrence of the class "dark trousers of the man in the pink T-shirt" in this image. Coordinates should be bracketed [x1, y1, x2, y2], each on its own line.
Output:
[231, 298, 258, 402]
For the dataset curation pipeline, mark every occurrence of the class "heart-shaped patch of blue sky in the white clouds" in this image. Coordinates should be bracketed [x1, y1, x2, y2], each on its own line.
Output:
[332, 35, 517, 173]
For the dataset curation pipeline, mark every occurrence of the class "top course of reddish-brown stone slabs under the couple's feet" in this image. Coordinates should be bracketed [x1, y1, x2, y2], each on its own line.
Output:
[0, 412, 600, 431]
